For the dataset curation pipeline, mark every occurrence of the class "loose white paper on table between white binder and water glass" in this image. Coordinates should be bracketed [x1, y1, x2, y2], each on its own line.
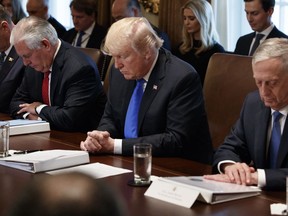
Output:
[47, 163, 132, 179]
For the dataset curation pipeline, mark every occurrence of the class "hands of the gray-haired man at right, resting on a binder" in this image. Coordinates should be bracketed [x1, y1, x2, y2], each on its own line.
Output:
[204, 163, 258, 185]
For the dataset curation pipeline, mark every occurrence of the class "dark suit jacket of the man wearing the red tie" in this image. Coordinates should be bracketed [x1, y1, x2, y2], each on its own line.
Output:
[10, 41, 106, 131]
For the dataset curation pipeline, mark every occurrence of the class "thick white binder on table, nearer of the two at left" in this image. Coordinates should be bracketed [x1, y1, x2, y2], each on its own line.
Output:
[0, 149, 90, 173]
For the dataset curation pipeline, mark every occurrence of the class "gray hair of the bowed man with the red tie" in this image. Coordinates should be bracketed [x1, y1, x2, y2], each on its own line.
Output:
[10, 16, 58, 50]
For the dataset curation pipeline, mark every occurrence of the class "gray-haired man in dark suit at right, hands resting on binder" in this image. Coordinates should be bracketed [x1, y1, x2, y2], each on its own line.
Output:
[206, 38, 288, 190]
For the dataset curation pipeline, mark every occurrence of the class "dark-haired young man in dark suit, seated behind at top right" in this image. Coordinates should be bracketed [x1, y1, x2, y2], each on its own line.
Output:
[234, 0, 288, 56]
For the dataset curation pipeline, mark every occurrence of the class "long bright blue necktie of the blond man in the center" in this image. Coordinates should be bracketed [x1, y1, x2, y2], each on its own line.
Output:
[124, 79, 145, 138]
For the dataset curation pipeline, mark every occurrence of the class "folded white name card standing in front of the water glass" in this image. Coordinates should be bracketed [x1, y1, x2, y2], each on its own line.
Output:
[144, 178, 199, 208]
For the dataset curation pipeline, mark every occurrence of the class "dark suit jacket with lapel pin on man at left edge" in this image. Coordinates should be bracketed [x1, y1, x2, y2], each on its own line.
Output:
[0, 47, 25, 113]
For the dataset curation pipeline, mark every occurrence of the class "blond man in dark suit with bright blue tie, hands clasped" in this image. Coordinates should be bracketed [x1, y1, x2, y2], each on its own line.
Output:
[80, 17, 213, 163]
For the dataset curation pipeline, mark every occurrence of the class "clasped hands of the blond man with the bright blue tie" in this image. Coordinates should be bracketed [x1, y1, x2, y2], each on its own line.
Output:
[80, 130, 114, 153]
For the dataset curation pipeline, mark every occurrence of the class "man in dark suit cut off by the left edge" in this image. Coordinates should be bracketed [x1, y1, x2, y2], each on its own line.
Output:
[0, 5, 25, 113]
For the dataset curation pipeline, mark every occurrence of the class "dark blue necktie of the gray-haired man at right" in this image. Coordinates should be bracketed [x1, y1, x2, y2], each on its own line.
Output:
[269, 111, 282, 169]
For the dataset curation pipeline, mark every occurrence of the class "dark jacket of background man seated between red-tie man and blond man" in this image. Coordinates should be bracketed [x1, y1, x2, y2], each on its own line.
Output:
[64, 23, 107, 49]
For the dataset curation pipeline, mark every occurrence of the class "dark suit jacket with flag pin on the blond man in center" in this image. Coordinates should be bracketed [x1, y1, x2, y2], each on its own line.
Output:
[98, 49, 213, 163]
